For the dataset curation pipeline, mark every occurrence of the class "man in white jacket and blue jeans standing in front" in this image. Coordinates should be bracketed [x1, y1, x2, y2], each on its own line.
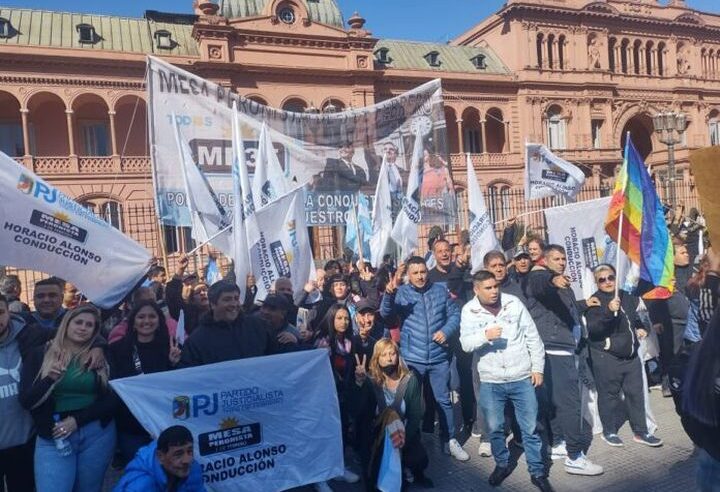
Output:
[460, 270, 553, 492]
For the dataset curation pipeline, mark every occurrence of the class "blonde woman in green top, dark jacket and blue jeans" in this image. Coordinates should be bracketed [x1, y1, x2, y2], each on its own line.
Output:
[20, 304, 115, 492]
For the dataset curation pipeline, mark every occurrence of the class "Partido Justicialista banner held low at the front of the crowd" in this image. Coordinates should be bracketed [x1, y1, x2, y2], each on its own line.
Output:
[110, 349, 344, 492]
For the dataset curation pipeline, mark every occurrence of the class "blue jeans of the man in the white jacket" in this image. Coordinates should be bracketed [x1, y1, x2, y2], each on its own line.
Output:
[479, 378, 545, 477]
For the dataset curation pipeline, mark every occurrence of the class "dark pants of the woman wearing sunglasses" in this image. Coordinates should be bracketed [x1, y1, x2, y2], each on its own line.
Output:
[590, 349, 647, 435]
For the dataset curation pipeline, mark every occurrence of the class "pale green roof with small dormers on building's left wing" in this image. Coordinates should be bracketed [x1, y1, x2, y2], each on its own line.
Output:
[0, 7, 198, 56]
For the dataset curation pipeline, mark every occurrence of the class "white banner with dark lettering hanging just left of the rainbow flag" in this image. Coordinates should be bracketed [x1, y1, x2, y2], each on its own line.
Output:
[545, 197, 638, 300]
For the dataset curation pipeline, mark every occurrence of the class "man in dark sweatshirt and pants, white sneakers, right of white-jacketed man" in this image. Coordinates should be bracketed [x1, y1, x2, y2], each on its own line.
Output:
[526, 244, 603, 475]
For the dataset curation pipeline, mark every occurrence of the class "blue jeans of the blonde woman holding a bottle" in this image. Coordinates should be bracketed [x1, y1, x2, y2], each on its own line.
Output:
[35, 420, 115, 492]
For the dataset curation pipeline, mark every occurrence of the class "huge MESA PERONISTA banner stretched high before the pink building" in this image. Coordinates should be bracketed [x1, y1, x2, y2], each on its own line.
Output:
[147, 57, 457, 226]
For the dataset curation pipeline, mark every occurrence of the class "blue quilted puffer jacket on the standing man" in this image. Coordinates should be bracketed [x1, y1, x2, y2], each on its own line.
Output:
[380, 282, 460, 364]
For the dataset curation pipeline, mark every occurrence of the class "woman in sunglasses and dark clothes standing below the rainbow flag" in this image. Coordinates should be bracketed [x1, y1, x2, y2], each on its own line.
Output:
[585, 264, 662, 447]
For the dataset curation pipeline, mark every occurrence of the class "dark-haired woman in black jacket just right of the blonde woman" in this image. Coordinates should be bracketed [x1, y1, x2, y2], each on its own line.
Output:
[108, 301, 181, 463]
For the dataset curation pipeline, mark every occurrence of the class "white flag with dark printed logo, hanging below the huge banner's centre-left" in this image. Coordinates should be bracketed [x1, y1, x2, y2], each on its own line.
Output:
[250, 187, 315, 301]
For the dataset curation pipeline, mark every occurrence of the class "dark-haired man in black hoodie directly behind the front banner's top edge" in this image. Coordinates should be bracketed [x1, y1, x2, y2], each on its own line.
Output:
[179, 280, 277, 367]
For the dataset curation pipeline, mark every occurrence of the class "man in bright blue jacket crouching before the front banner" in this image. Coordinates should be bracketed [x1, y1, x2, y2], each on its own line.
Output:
[113, 425, 205, 492]
